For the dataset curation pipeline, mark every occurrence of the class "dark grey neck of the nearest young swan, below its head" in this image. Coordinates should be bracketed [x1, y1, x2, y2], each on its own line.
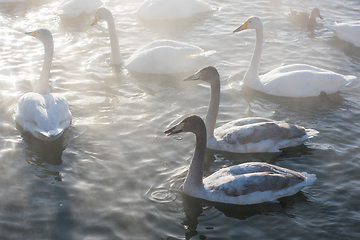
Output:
[184, 127, 206, 190]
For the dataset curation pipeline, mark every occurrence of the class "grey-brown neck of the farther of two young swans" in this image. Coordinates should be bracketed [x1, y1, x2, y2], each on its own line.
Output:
[205, 79, 220, 139]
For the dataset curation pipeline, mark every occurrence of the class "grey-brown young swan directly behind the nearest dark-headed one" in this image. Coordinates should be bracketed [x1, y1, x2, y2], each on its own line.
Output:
[184, 66, 318, 153]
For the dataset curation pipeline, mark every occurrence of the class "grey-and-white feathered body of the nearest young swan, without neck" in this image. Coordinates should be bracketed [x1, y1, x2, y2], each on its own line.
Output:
[204, 163, 316, 204]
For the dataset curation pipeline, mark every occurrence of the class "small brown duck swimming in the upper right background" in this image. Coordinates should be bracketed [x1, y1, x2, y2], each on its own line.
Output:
[288, 8, 323, 27]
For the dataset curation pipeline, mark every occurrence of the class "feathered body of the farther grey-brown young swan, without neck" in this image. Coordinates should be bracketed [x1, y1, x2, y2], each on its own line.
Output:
[208, 118, 310, 153]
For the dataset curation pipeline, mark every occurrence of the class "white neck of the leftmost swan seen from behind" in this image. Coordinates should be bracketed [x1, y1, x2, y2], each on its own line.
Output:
[33, 37, 54, 95]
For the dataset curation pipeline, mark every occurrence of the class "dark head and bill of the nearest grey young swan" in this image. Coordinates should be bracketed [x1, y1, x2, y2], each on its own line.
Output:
[164, 115, 206, 136]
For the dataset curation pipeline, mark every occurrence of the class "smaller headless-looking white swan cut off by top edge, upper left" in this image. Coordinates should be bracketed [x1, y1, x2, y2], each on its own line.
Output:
[59, 0, 102, 18]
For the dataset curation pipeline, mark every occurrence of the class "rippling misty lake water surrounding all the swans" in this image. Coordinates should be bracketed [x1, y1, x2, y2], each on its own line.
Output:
[0, 0, 360, 239]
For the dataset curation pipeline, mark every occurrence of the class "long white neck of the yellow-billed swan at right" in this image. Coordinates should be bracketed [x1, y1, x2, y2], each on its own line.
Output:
[244, 27, 263, 83]
